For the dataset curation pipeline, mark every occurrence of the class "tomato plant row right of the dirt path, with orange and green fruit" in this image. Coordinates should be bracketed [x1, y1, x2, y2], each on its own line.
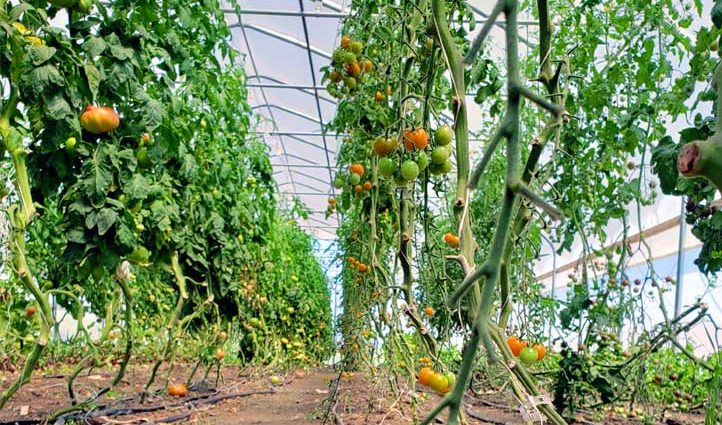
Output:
[324, 0, 722, 424]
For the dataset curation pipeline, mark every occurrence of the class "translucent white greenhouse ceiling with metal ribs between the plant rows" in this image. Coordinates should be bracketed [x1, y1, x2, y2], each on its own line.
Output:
[224, 0, 534, 240]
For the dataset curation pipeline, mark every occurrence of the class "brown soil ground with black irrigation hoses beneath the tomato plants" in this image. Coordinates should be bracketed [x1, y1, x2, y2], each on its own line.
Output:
[0, 365, 704, 425]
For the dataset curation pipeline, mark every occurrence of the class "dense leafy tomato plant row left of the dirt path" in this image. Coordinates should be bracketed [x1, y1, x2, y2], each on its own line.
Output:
[0, 0, 332, 416]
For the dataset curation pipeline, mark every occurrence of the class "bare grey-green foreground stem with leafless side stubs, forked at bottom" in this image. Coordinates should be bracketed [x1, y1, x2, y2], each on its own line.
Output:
[421, 0, 566, 425]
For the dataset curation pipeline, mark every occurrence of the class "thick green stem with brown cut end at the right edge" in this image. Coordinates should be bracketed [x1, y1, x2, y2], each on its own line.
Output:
[677, 62, 722, 192]
